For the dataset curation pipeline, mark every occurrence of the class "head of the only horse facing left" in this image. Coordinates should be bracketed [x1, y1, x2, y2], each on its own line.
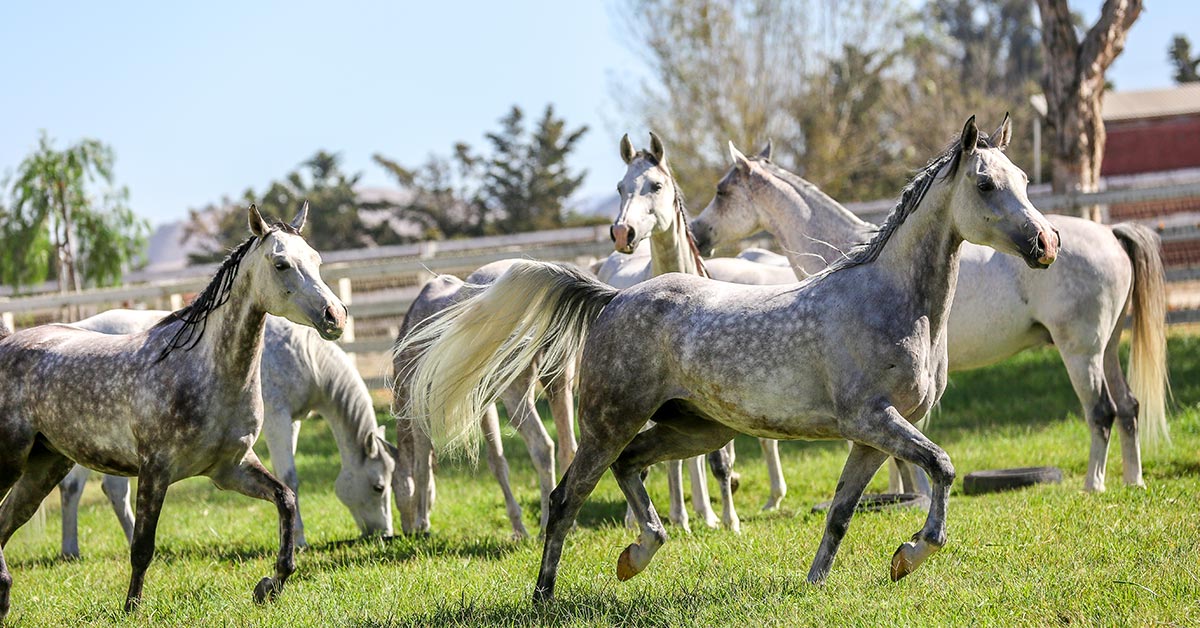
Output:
[691, 142, 770, 255]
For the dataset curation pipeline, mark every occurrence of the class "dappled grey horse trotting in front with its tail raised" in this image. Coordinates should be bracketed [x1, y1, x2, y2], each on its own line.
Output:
[398, 116, 1060, 600]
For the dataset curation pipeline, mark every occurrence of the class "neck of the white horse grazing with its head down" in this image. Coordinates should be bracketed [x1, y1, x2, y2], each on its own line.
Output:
[302, 334, 379, 466]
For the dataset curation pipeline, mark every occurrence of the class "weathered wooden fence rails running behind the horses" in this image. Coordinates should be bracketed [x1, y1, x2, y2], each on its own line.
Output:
[7, 181, 1200, 387]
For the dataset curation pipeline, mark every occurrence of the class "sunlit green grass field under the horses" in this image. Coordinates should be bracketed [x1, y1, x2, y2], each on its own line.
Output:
[5, 336, 1200, 626]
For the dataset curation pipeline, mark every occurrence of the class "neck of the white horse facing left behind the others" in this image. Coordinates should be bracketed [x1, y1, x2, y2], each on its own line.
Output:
[761, 177, 875, 273]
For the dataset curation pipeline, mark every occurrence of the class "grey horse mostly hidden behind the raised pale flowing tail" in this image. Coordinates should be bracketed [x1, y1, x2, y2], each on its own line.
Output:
[392, 259, 576, 539]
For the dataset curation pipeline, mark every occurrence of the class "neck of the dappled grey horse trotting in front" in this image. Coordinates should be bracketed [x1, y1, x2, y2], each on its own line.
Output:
[871, 183, 962, 339]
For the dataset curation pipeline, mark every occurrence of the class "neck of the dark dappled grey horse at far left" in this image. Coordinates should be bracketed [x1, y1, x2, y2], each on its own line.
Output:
[197, 277, 266, 391]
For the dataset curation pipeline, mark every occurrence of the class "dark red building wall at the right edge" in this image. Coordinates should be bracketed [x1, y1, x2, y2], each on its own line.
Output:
[1100, 115, 1200, 177]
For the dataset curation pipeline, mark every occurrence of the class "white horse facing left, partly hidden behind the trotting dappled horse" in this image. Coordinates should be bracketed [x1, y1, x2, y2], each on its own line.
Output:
[691, 135, 1168, 491]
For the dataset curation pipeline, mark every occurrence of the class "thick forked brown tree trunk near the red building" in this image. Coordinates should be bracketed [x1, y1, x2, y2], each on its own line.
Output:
[1038, 0, 1142, 221]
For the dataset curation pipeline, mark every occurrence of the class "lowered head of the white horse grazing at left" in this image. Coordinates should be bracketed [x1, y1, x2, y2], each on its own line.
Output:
[334, 426, 396, 537]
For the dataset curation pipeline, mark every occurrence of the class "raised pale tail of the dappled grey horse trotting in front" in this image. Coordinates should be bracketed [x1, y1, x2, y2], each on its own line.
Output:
[392, 261, 617, 456]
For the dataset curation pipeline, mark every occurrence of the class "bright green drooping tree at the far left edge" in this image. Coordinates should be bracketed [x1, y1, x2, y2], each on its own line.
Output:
[0, 131, 150, 291]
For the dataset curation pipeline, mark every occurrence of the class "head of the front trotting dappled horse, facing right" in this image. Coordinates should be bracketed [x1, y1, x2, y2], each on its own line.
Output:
[950, 116, 1061, 268]
